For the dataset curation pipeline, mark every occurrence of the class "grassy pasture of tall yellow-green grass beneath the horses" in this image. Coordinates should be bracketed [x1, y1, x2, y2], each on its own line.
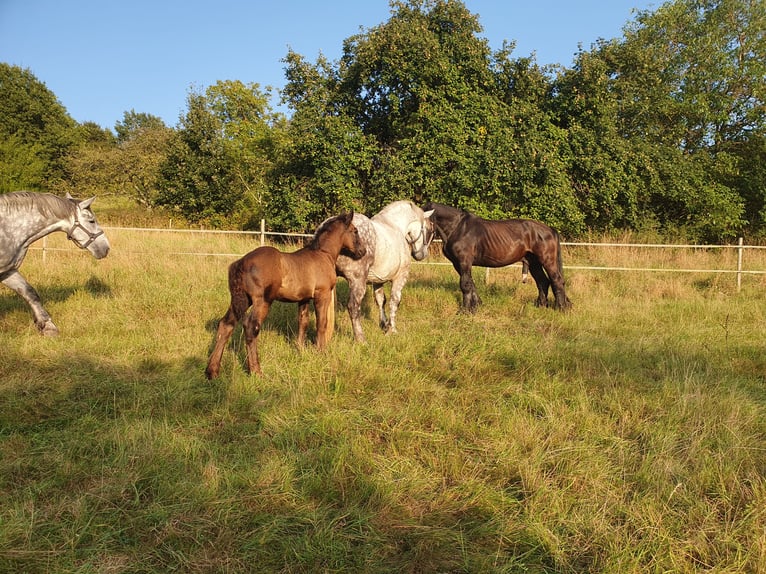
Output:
[0, 230, 766, 573]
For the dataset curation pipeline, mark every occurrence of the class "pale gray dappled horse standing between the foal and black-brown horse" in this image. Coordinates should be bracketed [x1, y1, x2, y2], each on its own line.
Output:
[335, 200, 434, 342]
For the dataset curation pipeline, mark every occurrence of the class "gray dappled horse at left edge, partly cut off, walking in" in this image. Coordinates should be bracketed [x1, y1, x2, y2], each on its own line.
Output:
[0, 191, 109, 335]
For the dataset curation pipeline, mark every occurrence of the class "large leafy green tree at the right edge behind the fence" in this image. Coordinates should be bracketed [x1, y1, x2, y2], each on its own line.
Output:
[552, 0, 766, 240]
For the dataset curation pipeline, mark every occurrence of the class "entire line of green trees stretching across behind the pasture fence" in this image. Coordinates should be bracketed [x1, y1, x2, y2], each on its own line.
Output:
[0, 0, 766, 241]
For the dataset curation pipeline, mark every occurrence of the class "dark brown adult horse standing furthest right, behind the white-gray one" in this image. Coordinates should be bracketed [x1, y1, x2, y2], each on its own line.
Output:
[423, 202, 572, 313]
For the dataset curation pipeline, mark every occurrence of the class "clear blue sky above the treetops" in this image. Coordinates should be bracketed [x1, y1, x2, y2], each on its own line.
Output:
[0, 0, 662, 129]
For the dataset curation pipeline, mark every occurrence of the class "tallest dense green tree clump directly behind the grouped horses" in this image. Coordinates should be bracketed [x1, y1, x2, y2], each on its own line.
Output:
[285, 0, 582, 234]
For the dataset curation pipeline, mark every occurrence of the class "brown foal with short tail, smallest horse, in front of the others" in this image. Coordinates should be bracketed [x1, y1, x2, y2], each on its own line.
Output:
[205, 212, 365, 379]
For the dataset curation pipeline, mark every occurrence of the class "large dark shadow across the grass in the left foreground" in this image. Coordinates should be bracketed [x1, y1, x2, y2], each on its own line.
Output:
[0, 346, 564, 572]
